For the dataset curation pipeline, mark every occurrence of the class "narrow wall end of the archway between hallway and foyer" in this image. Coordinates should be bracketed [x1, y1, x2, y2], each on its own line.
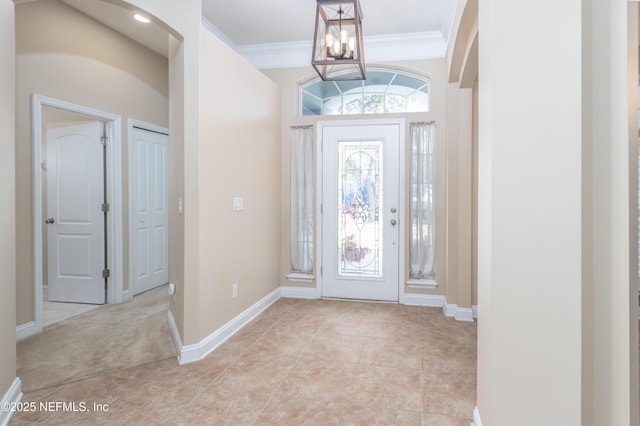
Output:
[121, 0, 202, 344]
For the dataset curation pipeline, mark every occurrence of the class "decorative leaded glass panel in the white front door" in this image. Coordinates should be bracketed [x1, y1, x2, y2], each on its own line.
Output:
[337, 141, 383, 278]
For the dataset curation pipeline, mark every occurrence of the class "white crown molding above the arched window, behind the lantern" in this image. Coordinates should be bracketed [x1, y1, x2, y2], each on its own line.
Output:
[232, 27, 447, 69]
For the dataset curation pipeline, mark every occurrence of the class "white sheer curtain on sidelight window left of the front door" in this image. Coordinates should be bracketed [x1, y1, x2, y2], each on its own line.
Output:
[289, 126, 313, 274]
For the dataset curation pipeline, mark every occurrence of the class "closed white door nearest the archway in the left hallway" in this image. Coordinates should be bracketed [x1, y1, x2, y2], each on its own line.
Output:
[130, 127, 169, 294]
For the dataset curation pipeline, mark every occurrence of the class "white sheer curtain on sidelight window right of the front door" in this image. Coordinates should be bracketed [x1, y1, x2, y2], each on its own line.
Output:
[409, 123, 436, 279]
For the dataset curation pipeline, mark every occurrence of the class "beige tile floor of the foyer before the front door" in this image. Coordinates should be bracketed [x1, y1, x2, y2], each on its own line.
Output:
[10, 299, 476, 426]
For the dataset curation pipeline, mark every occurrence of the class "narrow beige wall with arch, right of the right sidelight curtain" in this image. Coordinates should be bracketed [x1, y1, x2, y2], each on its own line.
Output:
[447, 0, 478, 307]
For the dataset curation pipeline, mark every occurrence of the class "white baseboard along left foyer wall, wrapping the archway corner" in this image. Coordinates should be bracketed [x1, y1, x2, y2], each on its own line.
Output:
[168, 287, 280, 365]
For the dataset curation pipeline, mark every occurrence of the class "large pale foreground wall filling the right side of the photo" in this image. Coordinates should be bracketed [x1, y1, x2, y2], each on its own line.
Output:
[478, 0, 639, 426]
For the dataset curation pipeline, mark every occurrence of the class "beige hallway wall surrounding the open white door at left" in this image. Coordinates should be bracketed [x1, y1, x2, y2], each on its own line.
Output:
[16, 0, 169, 324]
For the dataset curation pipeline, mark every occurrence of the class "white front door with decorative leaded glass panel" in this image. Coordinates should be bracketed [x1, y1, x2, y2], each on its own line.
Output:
[319, 122, 401, 301]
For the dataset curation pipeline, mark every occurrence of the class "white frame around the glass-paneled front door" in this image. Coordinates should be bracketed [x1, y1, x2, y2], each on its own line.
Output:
[315, 119, 407, 304]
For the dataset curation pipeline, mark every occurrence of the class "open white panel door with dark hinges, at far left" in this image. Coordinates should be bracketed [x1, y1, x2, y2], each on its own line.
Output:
[46, 122, 106, 304]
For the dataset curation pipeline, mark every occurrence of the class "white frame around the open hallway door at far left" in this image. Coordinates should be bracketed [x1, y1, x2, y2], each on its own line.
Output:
[31, 93, 124, 337]
